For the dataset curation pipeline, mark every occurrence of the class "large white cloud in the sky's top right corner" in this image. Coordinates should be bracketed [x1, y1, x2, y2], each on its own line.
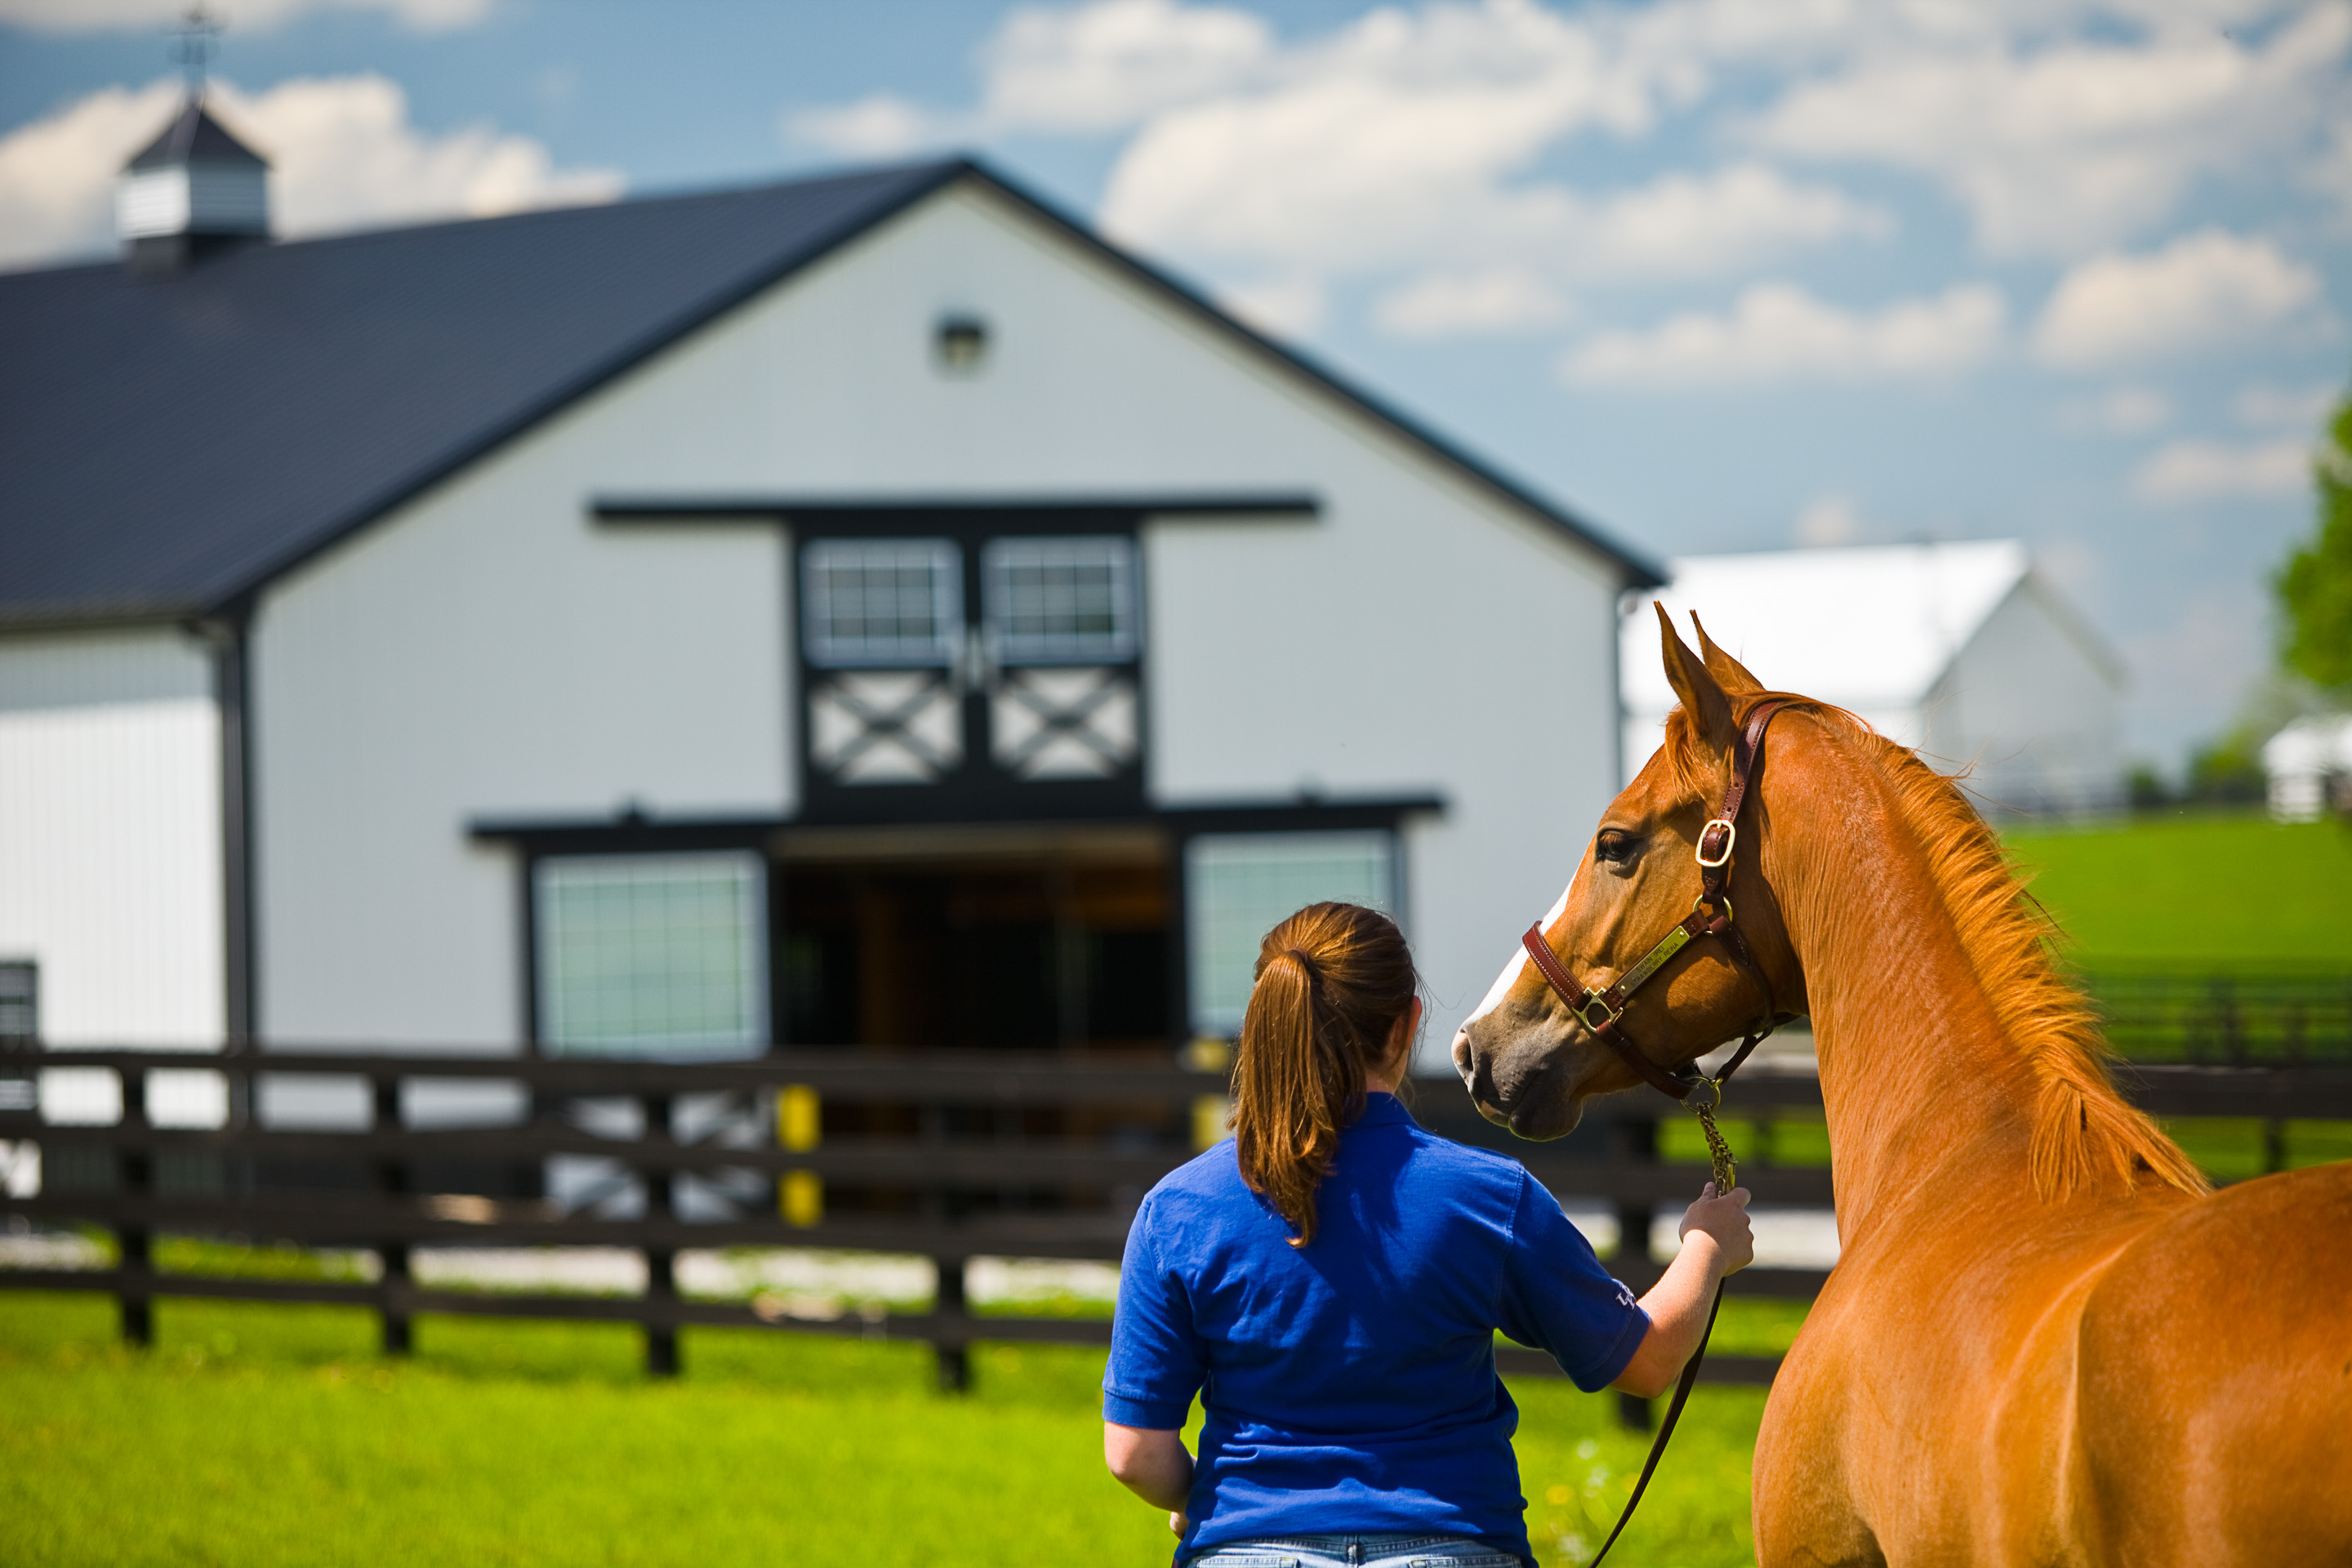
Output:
[1754, 0, 2352, 256]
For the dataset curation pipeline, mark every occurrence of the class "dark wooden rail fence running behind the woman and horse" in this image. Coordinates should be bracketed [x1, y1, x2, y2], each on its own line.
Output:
[0, 1051, 2352, 1419]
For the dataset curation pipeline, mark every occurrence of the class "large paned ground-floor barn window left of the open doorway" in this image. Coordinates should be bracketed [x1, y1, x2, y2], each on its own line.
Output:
[532, 853, 767, 1058]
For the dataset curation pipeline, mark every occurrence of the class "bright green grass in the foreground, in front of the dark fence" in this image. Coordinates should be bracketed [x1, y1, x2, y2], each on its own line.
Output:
[0, 1290, 1794, 1568]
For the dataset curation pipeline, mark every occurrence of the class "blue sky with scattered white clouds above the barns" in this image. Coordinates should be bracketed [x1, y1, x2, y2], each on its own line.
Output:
[0, 0, 2352, 764]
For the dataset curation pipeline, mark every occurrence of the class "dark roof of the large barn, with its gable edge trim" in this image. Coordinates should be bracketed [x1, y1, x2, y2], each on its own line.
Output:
[0, 160, 1663, 626]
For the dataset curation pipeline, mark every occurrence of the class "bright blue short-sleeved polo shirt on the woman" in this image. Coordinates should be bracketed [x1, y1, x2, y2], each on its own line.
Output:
[1103, 1094, 1649, 1557]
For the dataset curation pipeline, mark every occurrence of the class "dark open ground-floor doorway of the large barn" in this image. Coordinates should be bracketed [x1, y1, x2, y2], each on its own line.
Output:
[769, 825, 1181, 1055]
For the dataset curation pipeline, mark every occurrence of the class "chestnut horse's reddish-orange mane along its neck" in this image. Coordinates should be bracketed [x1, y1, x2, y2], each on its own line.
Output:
[1665, 691, 2213, 1199]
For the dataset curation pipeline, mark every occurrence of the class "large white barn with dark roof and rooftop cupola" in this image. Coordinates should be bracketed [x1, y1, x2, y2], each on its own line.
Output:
[0, 106, 1658, 1081]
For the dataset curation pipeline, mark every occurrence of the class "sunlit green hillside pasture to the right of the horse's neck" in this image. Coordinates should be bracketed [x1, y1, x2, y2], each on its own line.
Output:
[2007, 811, 2352, 969]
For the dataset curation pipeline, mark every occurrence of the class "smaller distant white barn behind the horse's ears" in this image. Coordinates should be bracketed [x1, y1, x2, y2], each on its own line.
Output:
[1623, 538, 2124, 816]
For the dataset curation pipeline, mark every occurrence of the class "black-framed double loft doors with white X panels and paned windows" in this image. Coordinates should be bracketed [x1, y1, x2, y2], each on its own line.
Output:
[800, 514, 1143, 821]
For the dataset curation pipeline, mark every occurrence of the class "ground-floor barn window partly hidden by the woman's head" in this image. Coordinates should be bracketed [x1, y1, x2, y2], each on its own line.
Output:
[1186, 832, 1397, 1036]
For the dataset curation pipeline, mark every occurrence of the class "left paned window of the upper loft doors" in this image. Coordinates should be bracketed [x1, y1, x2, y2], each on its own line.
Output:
[800, 538, 964, 668]
